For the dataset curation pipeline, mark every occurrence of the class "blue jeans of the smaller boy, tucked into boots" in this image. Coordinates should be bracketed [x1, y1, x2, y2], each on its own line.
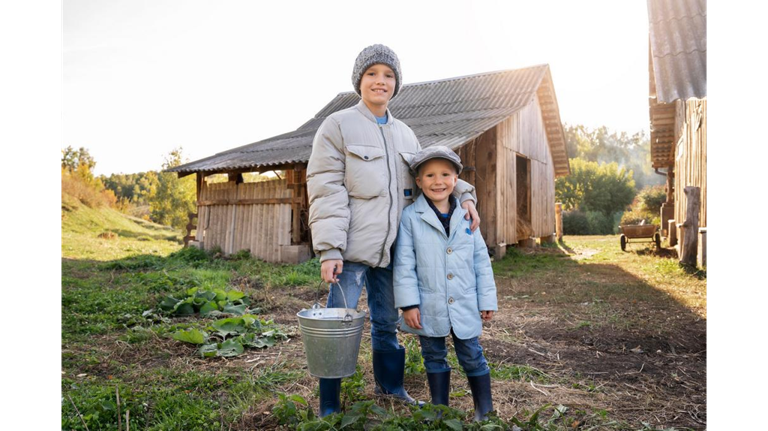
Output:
[419, 329, 491, 377]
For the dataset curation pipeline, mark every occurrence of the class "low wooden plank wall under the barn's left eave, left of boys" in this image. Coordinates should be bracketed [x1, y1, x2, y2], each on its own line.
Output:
[198, 179, 293, 262]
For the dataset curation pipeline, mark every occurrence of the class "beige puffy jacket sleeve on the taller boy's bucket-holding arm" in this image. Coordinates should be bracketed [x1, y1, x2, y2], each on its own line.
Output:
[307, 117, 350, 262]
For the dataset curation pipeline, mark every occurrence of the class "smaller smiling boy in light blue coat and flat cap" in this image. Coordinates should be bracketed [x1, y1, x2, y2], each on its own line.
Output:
[394, 146, 498, 421]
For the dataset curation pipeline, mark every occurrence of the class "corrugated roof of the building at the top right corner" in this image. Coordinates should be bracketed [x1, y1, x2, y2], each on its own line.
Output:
[648, 0, 707, 103]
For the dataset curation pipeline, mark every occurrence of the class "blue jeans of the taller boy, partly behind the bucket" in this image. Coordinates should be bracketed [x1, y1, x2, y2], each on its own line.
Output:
[326, 261, 400, 351]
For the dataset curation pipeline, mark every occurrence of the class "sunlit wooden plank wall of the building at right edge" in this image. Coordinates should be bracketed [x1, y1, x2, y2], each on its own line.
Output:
[675, 99, 707, 227]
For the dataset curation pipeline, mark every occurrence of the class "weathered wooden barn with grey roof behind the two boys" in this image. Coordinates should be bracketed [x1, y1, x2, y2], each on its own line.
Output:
[167, 64, 570, 263]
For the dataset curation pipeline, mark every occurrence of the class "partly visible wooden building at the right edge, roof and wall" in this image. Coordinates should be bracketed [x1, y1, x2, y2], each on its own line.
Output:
[648, 0, 708, 266]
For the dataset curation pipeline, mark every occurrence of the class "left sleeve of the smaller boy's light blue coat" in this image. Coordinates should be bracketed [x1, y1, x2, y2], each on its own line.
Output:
[393, 206, 421, 308]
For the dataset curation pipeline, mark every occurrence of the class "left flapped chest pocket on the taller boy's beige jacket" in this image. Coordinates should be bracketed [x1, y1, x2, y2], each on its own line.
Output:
[344, 145, 389, 199]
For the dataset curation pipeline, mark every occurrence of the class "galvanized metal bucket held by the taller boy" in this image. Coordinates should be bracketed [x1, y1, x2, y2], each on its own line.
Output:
[296, 286, 365, 379]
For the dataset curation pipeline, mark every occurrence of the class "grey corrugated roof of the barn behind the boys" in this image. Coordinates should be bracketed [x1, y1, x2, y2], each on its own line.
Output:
[168, 65, 570, 175]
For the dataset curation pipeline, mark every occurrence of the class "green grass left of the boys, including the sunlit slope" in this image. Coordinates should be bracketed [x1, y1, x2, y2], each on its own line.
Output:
[61, 203, 320, 430]
